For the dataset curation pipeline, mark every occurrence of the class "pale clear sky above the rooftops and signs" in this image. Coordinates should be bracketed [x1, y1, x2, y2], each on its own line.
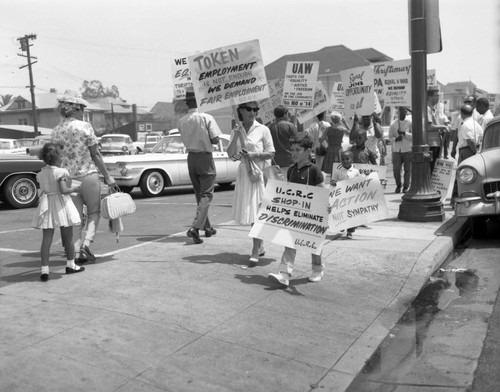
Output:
[0, 0, 500, 108]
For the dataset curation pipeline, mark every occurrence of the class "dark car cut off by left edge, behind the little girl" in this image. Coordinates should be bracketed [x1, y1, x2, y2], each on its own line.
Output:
[0, 154, 45, 208]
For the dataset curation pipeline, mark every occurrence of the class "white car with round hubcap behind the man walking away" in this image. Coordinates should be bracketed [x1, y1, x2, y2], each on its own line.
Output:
[104, 134, 239, 197]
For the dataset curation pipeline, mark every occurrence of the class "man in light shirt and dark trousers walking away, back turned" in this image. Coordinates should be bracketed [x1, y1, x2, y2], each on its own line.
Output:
[177, 91, 222, 244]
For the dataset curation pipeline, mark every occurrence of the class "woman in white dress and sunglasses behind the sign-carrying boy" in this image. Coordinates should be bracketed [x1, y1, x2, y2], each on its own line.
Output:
[227, 101, 275, 264]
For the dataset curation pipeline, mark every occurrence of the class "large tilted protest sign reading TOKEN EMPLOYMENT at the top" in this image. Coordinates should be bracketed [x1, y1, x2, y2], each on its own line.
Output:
[188, 40, 269, 112]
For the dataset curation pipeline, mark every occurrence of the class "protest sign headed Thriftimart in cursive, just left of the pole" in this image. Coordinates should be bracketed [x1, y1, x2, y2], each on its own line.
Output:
[373, 59, 411, 106]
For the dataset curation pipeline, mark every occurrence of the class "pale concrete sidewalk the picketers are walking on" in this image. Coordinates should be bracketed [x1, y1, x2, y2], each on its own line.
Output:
[0, 174, 466, 392]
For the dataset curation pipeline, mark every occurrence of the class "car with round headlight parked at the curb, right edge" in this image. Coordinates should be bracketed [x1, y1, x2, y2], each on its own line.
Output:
[455, 116, 500, 238]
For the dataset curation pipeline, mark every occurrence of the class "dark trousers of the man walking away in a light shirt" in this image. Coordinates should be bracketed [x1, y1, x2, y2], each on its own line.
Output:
[187, 152, 216, 230]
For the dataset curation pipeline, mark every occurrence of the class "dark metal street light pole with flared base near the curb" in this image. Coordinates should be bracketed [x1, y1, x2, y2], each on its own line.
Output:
[398, 0, 444, 222]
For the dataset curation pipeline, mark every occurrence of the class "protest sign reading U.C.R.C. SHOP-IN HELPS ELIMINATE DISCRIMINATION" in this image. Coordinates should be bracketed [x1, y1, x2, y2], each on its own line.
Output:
[249, 179, 329, 254]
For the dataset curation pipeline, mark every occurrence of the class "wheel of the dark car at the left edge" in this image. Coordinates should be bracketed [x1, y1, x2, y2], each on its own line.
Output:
[3, 174, 38, 208]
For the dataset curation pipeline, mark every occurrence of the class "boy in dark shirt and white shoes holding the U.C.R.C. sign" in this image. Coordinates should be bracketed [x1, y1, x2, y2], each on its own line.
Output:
[268, 135, 325, 288]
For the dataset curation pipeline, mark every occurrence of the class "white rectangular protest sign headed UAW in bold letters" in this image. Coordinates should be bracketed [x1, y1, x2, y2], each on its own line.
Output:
[283, 61, 319, 109]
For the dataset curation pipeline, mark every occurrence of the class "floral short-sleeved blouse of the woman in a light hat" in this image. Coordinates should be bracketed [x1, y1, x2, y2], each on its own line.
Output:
[51, 118, 98, 178]
